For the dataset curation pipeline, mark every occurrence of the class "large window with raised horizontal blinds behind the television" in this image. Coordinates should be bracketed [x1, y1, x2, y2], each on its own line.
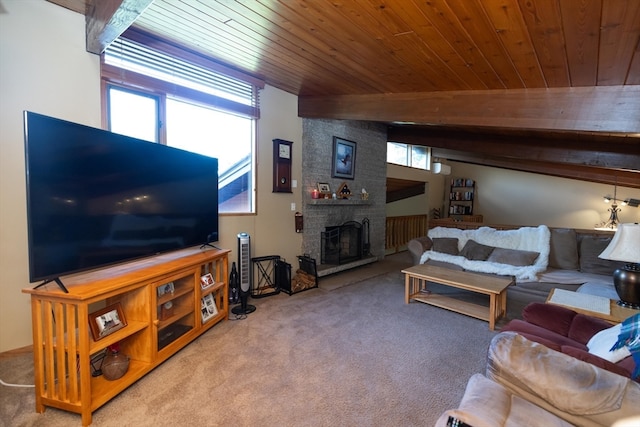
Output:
[101, 30, 264, 213]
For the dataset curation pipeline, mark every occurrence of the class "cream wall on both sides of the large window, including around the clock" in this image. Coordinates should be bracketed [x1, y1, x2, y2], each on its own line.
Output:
[0, 0, 302, 352]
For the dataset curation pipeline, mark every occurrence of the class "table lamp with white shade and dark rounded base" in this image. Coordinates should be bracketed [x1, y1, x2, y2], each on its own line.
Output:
[598, 223, 640, 310]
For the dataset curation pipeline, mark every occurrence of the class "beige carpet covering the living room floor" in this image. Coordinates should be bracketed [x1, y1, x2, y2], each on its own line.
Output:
[0, 252, 495, 426]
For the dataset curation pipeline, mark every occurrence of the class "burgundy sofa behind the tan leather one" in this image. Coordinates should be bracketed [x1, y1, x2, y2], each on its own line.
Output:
[500, 302, 637, 380]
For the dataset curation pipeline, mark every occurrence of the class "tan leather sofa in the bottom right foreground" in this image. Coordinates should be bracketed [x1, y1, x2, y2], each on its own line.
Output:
[436, 332, 640, 427]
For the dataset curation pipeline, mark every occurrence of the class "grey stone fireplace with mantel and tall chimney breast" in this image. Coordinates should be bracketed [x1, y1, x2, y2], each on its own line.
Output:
[301, 119, 387, 277]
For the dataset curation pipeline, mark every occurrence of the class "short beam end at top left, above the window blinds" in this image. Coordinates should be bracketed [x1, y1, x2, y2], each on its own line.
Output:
[85, 0, 153, 55]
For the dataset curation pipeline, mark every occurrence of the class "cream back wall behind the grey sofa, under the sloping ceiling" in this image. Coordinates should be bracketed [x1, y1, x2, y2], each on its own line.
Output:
[445, 162, 640, 229]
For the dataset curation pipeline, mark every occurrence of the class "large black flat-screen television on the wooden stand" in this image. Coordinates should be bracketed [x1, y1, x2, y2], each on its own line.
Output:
[24, 111, 218, 282]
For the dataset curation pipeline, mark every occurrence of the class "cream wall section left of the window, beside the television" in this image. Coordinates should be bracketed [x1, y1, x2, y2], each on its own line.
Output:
[0, 0, 100, 351]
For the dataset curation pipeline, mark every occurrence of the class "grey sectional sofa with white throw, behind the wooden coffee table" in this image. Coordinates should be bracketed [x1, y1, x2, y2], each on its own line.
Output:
[407, 222, 624, 306]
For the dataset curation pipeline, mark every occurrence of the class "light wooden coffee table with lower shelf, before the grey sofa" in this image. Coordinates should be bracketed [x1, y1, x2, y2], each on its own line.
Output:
[402, 264, 514, 330]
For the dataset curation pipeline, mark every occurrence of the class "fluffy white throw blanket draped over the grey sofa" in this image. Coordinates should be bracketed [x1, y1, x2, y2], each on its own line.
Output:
[420, 225, 551, 281]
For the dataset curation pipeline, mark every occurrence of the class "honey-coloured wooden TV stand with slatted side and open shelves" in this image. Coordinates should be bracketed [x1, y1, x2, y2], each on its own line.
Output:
[22, 248, 230, 426]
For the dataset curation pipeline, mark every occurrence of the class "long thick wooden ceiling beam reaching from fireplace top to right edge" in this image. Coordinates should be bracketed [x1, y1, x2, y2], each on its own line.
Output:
[298, 85, 640, 136]
